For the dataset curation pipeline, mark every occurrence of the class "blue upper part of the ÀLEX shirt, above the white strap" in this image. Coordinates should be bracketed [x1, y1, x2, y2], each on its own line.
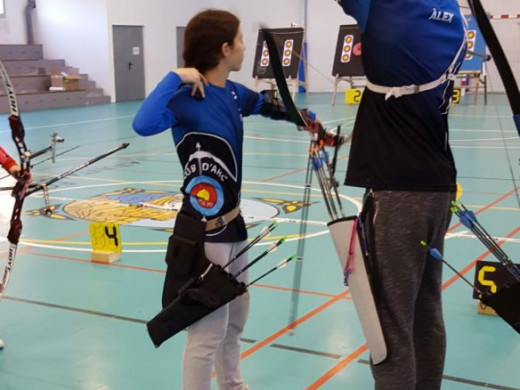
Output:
[340, 0, 464, 87]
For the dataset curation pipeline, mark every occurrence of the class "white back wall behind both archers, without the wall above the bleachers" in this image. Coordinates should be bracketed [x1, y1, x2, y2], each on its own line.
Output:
[108, 0, 520, 92]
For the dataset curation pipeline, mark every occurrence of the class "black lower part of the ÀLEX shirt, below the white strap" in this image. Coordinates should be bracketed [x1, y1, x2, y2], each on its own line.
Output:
[345, 84, 456, 192]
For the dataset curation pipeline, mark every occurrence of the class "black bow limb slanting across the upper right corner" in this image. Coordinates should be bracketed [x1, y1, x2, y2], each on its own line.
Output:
[468, 0, 520, 135]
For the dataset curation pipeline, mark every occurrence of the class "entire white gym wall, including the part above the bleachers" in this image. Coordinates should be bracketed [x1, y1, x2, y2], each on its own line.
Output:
[0, 0, 520, 96]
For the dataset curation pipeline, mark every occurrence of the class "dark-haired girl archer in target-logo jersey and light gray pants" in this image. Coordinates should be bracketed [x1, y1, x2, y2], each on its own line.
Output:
[133, 10, 338, 390]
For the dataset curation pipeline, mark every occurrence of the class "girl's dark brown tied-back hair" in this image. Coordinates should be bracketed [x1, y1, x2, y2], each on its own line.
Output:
[183, 10, 240, 73]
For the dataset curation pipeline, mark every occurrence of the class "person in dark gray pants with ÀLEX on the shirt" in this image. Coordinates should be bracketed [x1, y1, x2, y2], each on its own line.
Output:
[336, 0, 466, 390]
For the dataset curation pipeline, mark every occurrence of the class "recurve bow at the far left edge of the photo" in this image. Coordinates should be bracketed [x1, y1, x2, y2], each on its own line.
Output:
[0, 61, 31, 299]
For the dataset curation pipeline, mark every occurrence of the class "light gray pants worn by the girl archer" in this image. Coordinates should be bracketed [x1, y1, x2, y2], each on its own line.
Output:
[183, 241, 249, 390]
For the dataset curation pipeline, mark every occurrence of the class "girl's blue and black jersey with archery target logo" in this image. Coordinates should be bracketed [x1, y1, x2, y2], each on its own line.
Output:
[133, 72, 304, 242]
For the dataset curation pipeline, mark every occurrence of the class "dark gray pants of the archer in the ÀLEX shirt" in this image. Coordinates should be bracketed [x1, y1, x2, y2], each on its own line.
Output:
[365, 191, 454, 390]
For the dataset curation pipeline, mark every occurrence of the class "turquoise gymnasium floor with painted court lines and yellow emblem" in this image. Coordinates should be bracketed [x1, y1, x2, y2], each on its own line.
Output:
[0, 90, 520, 390]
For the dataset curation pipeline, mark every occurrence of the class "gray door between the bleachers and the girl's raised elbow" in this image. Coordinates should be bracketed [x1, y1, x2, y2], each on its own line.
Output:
[112, 26, 145, 102]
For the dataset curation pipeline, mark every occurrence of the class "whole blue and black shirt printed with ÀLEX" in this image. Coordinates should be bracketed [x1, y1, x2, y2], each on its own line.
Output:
[339, 0, 465, 191]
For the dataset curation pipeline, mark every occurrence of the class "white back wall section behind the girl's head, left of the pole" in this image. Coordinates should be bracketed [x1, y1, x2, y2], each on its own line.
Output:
[108, 0, 301, 96]
